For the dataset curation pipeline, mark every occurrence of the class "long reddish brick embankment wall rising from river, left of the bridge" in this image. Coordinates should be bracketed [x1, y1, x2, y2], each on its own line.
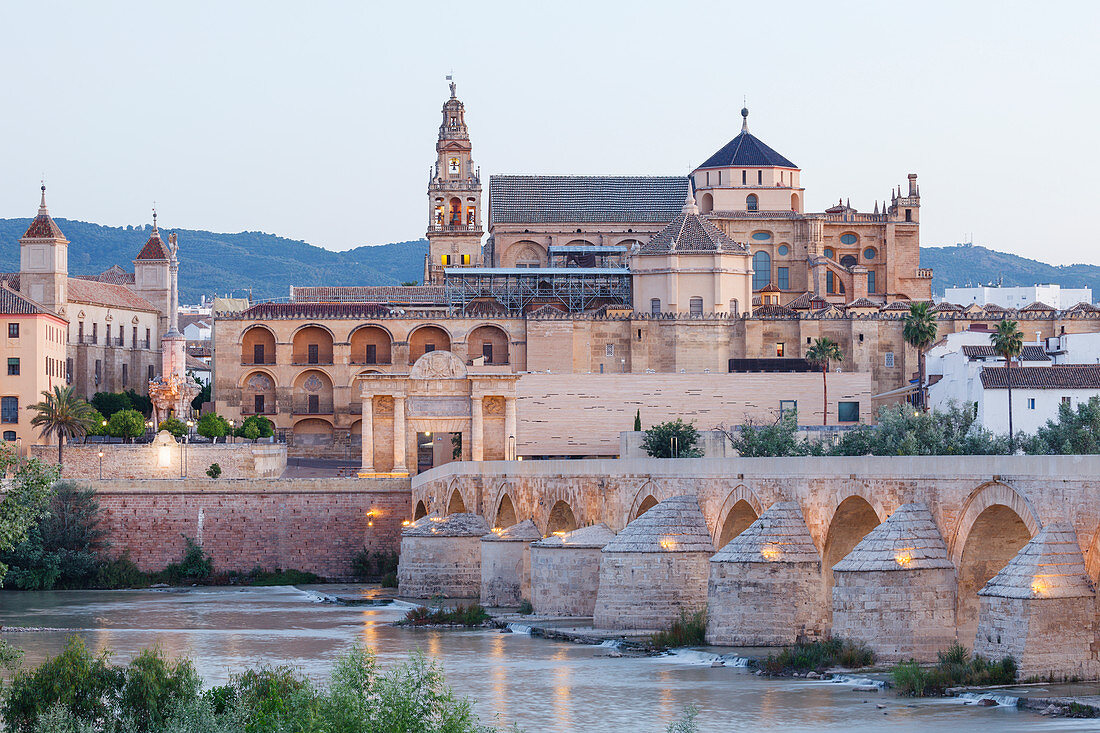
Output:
[73, 478, 411, 579]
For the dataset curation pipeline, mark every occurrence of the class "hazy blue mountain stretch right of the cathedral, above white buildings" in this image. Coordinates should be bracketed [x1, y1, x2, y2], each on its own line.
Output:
[921, 244, 1100, 305]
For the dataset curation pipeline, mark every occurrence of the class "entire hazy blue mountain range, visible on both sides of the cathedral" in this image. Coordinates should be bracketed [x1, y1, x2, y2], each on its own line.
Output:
[0, 219, 1100, 303]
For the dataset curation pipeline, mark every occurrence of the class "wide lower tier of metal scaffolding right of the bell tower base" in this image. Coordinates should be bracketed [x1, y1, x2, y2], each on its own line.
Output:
[443, 267, 630, 315]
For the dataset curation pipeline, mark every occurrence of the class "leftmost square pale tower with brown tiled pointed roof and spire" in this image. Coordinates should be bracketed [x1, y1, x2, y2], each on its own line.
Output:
[19, 183, 69, 314]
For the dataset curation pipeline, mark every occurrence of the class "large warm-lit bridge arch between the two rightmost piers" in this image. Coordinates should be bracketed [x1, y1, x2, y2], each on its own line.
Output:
[950, 482, 1041, 646]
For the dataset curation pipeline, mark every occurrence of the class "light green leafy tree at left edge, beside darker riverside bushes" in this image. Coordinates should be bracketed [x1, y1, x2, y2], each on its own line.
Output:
[0, 444, 59, 587]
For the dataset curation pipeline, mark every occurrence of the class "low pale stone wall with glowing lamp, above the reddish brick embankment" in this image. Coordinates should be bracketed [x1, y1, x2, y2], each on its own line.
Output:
[31, 442, 286, 480]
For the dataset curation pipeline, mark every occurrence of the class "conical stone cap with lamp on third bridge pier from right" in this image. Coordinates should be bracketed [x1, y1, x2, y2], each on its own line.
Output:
[711, 502, 822, 564]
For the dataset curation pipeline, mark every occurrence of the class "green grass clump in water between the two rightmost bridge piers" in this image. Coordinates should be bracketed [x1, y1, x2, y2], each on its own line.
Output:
[891, 644, 1016, 698]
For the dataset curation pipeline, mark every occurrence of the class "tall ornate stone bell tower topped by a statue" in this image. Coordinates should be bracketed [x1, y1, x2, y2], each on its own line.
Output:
[424, 77, 484, 285]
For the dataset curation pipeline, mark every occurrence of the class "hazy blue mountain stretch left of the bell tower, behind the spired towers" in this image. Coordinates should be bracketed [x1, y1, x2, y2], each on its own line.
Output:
[0, 219, 428, 303]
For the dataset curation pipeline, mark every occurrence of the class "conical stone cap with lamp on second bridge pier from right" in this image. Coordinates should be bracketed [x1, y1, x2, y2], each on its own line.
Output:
[833, 504, 955, 572]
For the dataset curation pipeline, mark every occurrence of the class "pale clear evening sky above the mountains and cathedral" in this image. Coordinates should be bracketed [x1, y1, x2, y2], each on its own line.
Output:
[0, 0, 1100, 264]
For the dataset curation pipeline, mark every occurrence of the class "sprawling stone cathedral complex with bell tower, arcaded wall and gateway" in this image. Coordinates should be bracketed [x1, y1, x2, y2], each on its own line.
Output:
[213, 84, 1093, 474]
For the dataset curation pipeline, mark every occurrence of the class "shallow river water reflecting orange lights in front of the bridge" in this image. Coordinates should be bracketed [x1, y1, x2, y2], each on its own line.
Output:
[0, 588, 1097, 733]
